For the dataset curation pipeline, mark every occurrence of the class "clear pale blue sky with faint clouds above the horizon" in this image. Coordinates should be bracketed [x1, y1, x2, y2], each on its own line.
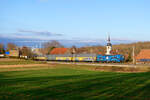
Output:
[0, 0, 150, 41]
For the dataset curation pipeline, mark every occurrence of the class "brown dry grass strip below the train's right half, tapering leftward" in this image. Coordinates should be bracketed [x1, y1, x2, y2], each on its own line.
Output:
[51, 64, 150, 73]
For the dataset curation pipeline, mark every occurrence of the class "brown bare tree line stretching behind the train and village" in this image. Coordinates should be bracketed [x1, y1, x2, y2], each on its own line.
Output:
[0, 40, 150, 61]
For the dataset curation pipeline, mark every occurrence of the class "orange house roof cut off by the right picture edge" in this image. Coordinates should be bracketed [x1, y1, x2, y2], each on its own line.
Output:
[136, 49, 150, 59]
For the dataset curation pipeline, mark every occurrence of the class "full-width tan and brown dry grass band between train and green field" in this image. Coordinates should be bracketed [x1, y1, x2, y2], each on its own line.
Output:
[0, 58, 150, 73]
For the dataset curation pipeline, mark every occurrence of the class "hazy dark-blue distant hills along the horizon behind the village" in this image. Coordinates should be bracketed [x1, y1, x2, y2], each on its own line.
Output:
[0, 37, 134, 48]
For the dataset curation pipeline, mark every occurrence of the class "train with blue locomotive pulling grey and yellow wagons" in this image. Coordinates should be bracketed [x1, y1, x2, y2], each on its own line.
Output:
[35, 54, 125, 63]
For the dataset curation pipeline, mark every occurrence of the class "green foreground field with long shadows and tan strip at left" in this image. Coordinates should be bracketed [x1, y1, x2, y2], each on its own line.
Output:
[0, 58, 150, 100]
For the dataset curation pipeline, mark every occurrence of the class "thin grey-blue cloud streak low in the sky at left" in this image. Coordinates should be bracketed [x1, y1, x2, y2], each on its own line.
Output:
[18, 29, 63, 36]
